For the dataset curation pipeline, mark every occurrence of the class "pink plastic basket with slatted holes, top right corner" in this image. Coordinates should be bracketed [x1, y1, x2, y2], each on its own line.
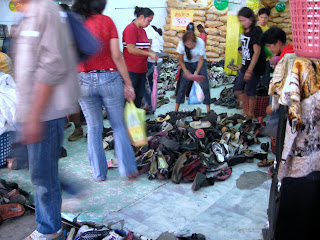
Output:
[290, 0, 320, 58]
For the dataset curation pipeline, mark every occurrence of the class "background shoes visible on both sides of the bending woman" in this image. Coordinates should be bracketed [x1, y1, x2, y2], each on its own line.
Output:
[159, 60, 235, 91]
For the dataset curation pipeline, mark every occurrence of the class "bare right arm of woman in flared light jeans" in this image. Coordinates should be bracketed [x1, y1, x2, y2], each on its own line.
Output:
[110, 38, 136, 101]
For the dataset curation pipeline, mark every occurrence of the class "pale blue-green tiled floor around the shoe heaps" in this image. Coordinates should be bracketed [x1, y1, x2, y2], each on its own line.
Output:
[0, 87, 273, 240]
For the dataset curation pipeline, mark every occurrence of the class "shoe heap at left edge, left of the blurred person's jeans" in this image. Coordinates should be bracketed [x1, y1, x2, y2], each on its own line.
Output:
[0, 179, 28, 223]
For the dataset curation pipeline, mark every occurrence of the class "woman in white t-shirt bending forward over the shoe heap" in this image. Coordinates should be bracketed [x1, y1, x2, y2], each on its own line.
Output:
[175, 31, 210, 112]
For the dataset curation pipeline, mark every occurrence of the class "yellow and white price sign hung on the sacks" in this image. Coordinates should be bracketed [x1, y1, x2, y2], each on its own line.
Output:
[171, 9, 193, 30]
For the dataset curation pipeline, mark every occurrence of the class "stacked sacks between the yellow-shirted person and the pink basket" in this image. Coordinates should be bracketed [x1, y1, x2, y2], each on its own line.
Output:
[260, 0, 292, 41]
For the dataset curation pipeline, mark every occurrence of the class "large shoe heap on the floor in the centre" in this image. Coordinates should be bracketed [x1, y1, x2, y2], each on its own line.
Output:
[127, 108, 268, 191]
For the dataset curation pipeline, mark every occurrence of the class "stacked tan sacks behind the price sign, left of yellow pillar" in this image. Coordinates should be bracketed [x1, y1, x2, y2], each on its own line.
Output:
[163, 0, 228, 62]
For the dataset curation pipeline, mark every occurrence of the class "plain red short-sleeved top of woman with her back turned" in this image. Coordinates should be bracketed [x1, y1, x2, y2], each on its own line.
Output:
[78, 14, 119, 72]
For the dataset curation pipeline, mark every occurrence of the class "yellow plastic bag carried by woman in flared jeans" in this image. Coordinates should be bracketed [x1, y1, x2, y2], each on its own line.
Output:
[124, 102, 147, 147]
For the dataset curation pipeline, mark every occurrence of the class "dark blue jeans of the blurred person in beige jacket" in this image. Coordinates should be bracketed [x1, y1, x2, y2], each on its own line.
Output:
[27, 118, 65, 234]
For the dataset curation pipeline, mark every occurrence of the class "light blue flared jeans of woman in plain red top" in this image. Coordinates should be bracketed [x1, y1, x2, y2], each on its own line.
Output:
[79, 72, 138, 181]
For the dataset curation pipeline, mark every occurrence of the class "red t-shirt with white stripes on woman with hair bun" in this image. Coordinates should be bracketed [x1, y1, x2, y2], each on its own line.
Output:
[122, 23, 150, 73]
